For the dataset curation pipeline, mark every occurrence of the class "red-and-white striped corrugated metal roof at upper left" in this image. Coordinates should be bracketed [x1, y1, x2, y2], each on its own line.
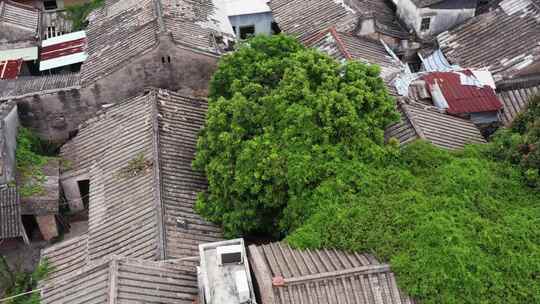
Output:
[39, 31, 88, 71]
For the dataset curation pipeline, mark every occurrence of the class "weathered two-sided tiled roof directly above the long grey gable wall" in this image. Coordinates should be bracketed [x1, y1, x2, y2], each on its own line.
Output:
[81, 0, 233, 83]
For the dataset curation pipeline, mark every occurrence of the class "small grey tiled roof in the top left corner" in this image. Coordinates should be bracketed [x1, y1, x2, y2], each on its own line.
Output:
[0, 0, 40, 49]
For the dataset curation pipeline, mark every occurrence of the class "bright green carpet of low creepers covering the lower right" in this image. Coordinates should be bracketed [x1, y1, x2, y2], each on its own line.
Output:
[287, 142, 540, 303]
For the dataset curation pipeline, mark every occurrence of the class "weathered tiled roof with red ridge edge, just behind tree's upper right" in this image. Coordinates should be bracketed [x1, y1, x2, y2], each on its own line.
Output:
[309, 28, 401, 81]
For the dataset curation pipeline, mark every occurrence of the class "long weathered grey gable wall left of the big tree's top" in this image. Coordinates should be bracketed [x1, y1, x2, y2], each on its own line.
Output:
[17, 35, 218, 143]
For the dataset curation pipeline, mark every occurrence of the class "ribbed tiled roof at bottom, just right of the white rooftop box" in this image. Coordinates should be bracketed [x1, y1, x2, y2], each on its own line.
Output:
[249, 243, 414, 304]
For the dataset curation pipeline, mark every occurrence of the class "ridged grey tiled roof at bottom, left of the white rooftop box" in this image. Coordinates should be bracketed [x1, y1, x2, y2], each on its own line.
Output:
[41, 257, 198, 304]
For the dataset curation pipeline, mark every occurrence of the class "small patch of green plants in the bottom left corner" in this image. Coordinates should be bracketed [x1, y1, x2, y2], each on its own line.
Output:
[0, 255, 51, 304]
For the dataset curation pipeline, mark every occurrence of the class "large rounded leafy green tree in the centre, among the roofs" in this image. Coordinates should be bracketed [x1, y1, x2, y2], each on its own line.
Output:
[194, 35, 397, 235]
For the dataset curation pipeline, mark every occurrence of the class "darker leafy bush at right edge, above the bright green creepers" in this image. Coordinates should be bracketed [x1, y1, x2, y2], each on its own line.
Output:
[491, 96, 540, 189]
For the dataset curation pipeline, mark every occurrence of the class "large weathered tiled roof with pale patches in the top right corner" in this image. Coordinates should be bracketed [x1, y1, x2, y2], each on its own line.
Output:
[437, 0, 540, 80]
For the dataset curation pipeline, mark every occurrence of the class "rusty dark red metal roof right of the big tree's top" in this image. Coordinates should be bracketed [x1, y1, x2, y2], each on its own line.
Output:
[421, 70, 502, 114]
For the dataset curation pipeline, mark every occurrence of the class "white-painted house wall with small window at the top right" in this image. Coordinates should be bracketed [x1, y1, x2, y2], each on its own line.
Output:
[393, 0, 475, 39]
